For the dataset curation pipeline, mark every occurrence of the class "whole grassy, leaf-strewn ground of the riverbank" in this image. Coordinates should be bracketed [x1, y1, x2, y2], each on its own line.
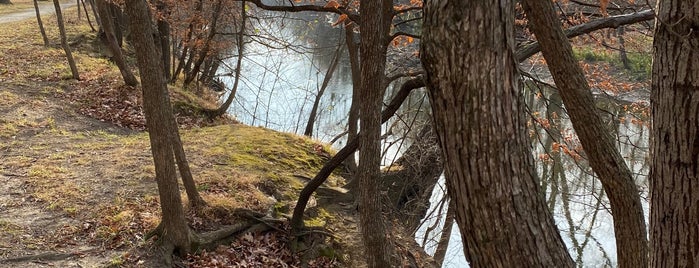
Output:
[0, 2, 370, 267]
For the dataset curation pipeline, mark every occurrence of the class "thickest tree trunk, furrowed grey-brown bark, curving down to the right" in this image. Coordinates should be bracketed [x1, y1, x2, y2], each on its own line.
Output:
[422, 0, 573, 267]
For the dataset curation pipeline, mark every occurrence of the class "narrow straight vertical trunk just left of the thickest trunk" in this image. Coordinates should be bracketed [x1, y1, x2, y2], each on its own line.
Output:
[357, 0, 396, 268]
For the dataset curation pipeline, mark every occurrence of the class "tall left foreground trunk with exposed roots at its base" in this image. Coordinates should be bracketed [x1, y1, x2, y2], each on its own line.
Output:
[126, 0, 191, 255]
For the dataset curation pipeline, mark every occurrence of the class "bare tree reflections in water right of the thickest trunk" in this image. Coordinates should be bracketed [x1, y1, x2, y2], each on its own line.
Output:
[524, 78, 648, 267]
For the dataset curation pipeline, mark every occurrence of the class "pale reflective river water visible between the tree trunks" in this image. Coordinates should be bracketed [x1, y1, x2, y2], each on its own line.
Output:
[221, 7, 648, 267]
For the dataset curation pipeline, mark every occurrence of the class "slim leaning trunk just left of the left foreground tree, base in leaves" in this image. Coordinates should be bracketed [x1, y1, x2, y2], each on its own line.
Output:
[95, 0, 138, 87]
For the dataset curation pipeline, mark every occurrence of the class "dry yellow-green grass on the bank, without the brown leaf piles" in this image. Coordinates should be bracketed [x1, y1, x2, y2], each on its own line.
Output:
[0, 4, 346, 267]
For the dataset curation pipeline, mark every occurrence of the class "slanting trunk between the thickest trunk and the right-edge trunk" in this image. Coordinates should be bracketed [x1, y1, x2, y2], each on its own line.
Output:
[522, 0, 648, 268]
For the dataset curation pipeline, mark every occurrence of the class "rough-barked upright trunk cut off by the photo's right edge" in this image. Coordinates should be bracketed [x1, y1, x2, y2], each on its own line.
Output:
[649, 0, 699, 267]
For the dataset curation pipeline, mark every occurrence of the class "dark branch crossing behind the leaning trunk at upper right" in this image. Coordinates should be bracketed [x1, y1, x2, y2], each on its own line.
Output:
[515, 9, 655, 62]
